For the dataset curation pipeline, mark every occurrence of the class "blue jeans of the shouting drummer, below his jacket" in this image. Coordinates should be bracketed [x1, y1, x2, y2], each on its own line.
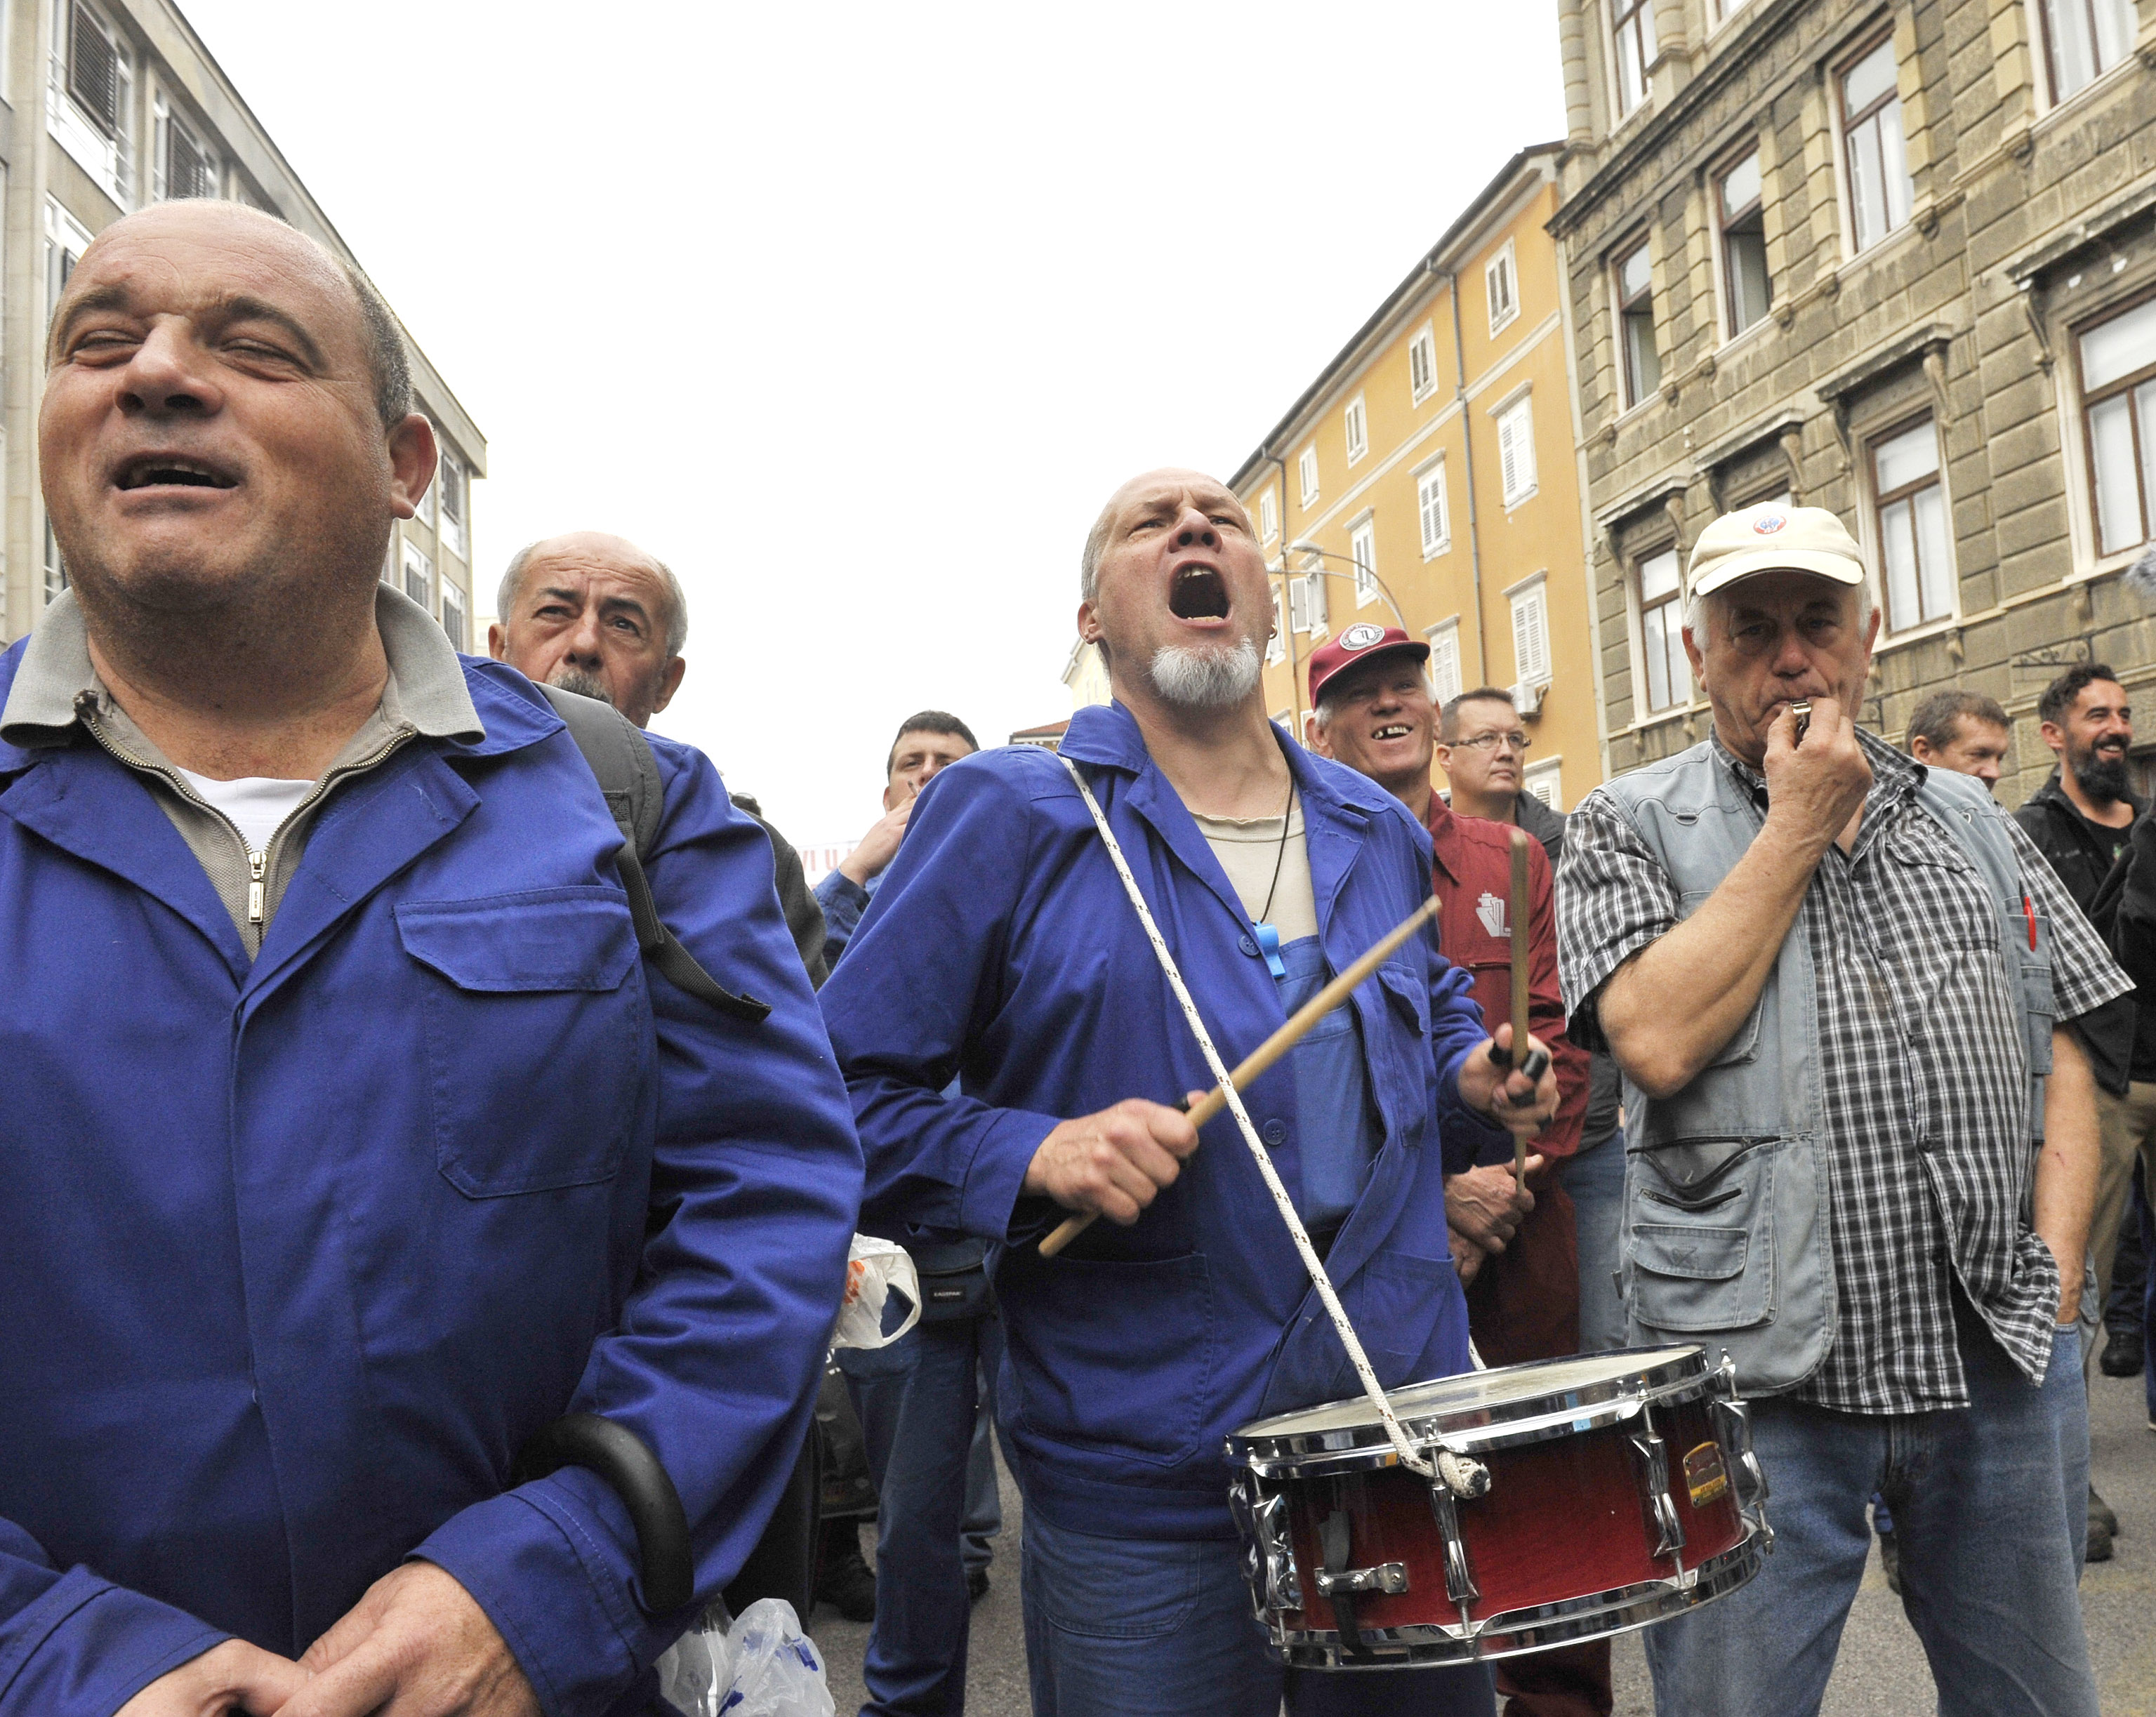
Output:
[1024, 1512, 1496, 1717]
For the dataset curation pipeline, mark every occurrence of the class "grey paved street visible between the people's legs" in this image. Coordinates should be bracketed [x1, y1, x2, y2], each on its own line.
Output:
[813, 1376, 2156, 1717]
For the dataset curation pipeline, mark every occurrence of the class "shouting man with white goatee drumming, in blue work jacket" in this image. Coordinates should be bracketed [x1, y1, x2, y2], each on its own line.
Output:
[824, 470, 1556, 1717]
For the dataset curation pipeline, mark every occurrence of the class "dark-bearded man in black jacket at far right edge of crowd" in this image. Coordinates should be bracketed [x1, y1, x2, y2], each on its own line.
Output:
[2013, 662, 2156, 1562]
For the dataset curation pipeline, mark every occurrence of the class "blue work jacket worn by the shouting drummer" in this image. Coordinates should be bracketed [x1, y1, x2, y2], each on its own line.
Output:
[821, 705, 1496, 1538]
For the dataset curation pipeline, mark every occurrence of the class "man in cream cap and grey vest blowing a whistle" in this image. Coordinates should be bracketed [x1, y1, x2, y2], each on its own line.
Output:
[1556, 505, 2126, 1717]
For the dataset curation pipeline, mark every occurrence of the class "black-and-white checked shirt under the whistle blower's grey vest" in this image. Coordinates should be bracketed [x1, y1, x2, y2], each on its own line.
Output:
[1556, 734, 2128, 1413]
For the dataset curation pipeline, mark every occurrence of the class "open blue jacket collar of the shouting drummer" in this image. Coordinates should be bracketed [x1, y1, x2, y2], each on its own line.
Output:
[1061, 703, 1415, 940]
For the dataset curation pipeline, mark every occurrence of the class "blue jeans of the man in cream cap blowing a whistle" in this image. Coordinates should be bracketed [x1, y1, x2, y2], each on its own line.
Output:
[1645, 1297, 2098, 1717]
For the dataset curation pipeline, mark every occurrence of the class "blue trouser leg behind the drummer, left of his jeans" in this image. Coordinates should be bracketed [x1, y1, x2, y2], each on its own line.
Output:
[839, 1315, 1003, 1717]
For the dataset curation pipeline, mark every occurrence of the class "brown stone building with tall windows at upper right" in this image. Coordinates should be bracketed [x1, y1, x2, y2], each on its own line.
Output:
[1550, 0, 2156, 804]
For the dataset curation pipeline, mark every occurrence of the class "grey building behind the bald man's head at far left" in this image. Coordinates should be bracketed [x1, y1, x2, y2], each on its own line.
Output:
[0, 0, 494, 649]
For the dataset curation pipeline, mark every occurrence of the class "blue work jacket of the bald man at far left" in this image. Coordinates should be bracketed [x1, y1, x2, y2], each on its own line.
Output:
[0, 643, 860, 1717]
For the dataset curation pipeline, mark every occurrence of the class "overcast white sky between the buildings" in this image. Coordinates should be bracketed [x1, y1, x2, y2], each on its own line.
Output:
[181, 0, 1563, 846]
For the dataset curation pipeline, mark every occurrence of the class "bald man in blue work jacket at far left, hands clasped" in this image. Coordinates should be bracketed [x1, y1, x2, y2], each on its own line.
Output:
[0, 201, 860, 1717]
